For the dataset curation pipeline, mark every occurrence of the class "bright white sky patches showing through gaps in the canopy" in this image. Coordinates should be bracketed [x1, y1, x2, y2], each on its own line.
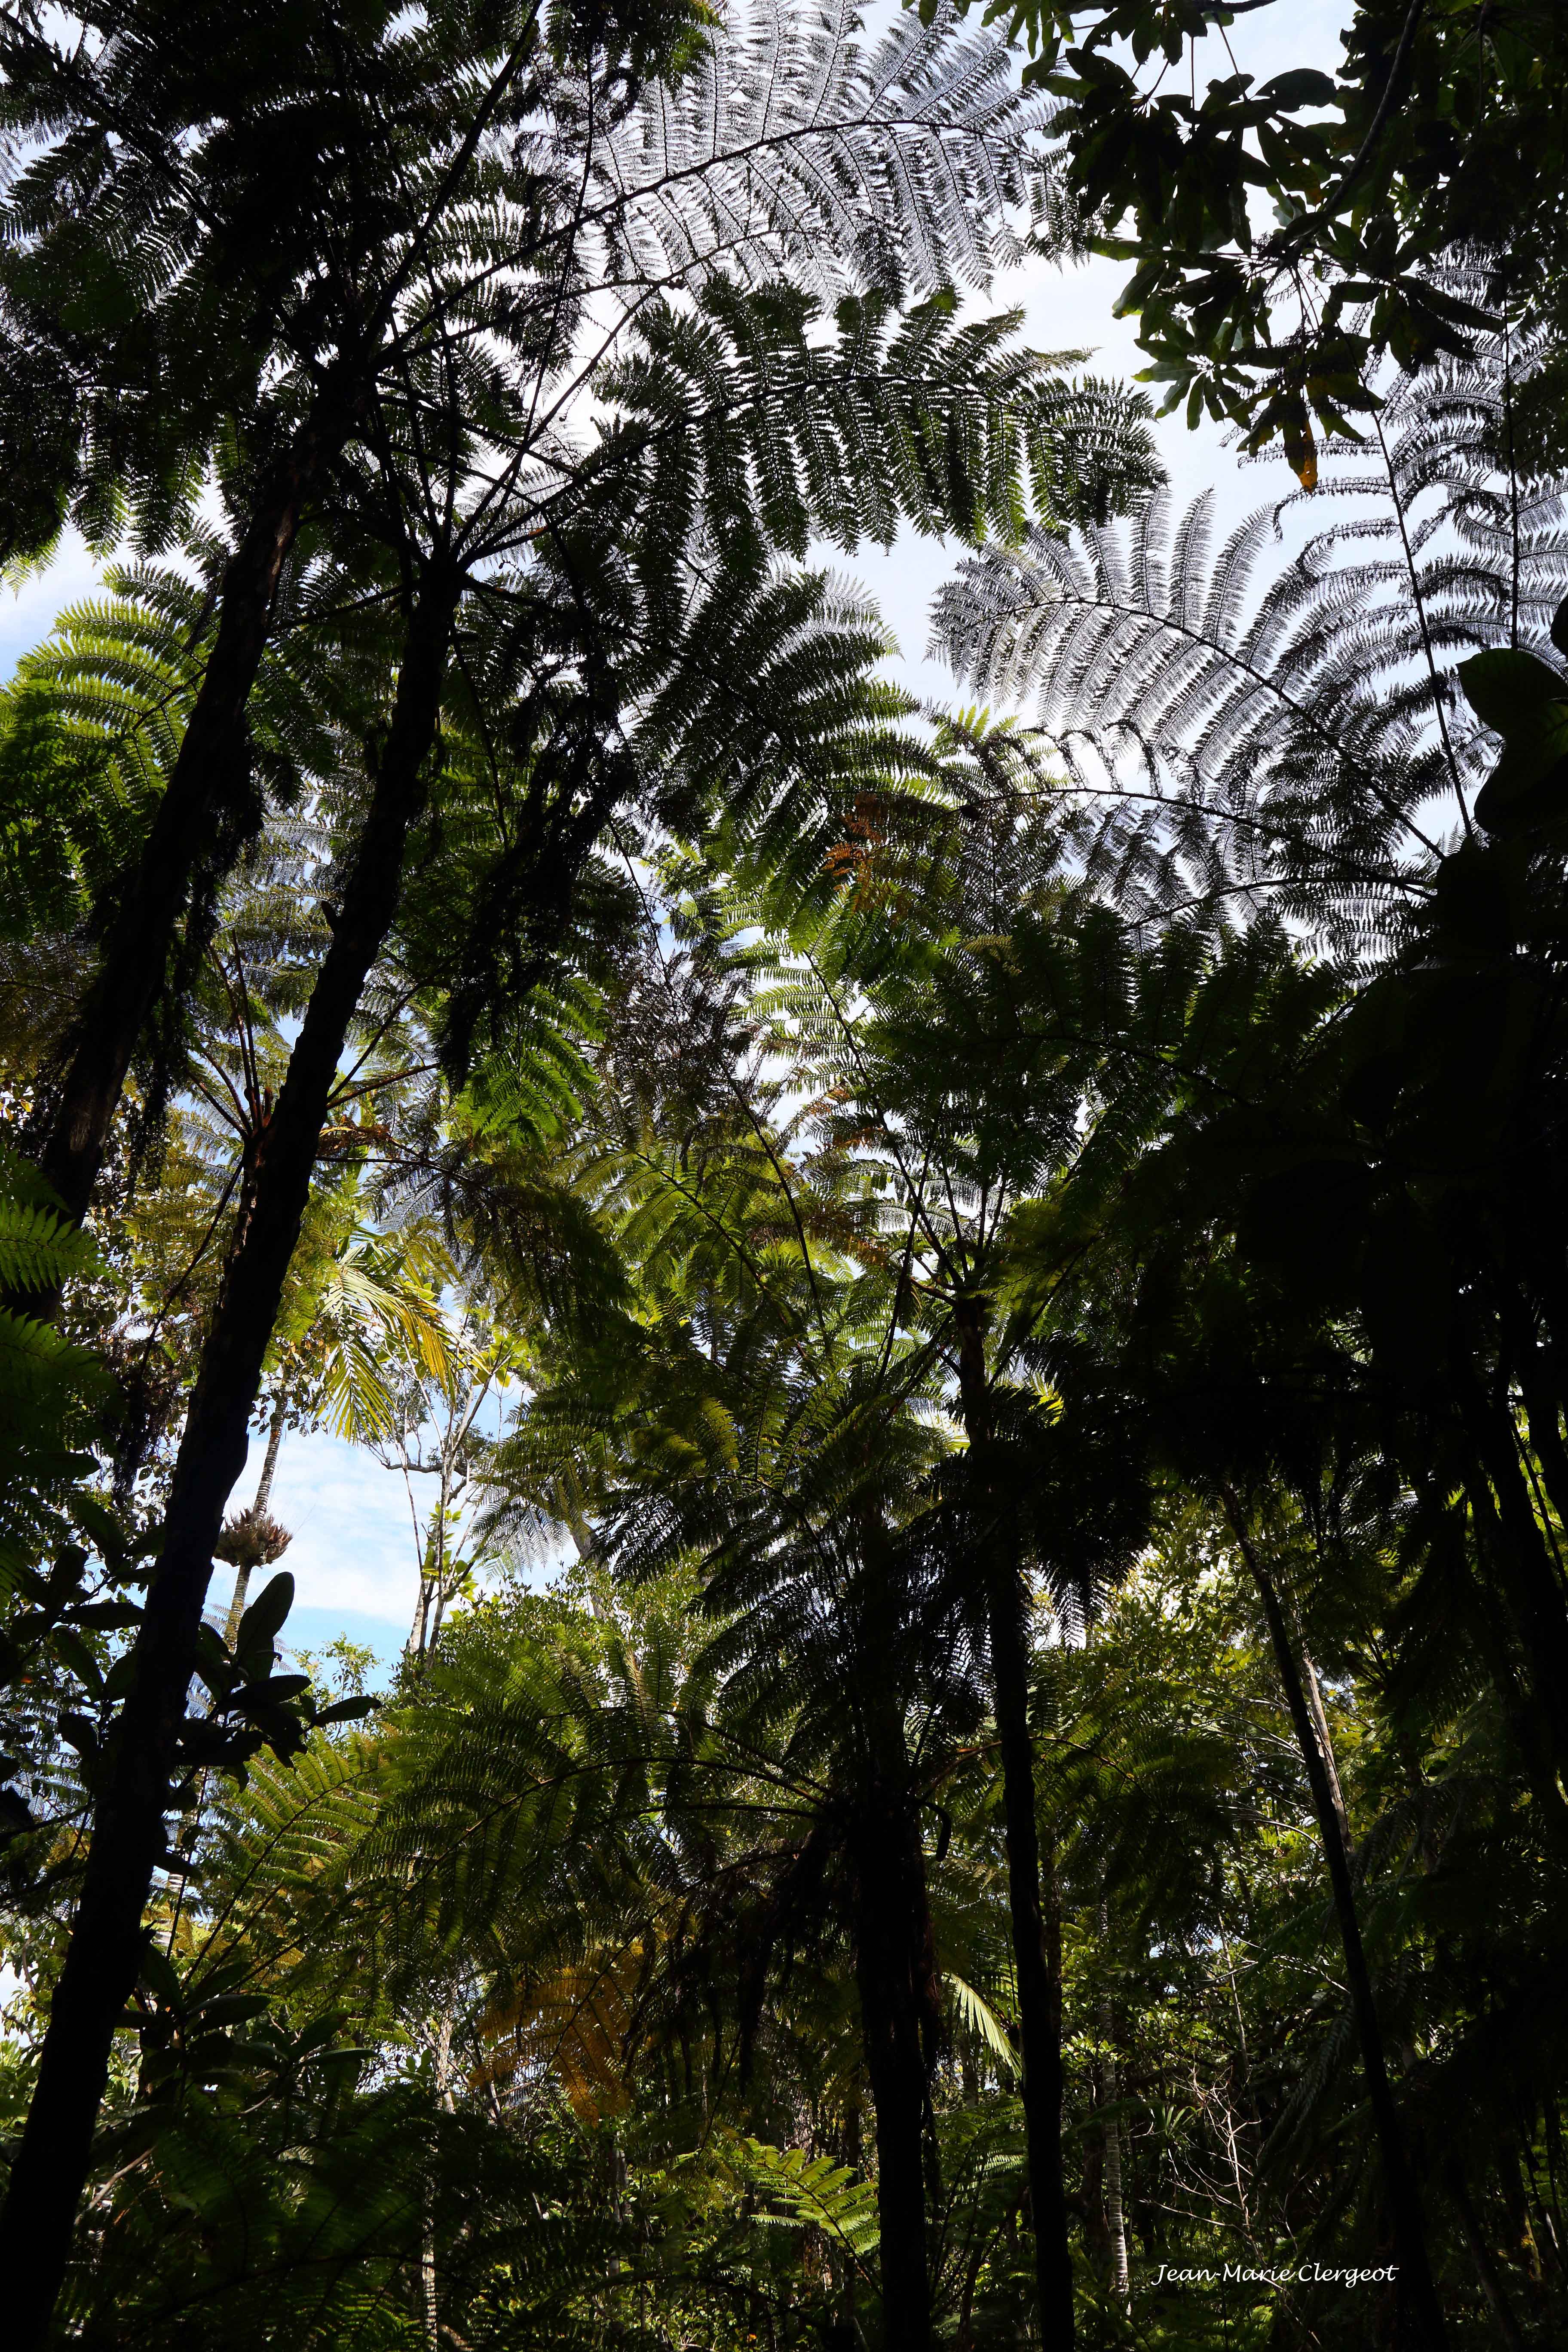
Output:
[0, 0, 1344, 1663]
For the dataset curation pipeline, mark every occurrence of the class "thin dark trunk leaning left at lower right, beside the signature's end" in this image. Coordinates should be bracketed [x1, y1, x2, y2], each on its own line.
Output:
[1220, 1489, 1448, 2352]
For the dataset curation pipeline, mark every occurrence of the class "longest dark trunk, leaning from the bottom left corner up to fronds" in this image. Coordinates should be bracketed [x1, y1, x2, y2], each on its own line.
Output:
[0, 572, 459, 2352]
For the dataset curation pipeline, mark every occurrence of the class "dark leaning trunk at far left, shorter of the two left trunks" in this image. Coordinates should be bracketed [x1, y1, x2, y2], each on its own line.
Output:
[28, 402, 352, 1260]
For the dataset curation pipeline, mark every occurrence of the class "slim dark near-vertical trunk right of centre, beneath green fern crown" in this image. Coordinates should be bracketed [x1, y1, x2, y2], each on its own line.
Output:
[955, 1301, 1074, 2352]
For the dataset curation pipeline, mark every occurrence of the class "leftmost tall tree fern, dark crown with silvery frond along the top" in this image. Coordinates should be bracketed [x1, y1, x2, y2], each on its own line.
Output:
[5, 0, 1067, 1251]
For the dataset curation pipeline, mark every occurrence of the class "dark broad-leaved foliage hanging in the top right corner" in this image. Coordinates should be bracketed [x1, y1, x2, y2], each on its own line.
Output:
[945, 0, 1568, 487]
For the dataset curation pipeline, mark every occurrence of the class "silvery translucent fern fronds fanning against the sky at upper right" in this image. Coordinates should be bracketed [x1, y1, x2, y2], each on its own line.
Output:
[936, 331, 1568, 955]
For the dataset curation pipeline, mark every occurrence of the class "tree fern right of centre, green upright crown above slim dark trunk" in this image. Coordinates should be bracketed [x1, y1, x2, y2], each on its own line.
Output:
[743, 722, 1161, 2345]
